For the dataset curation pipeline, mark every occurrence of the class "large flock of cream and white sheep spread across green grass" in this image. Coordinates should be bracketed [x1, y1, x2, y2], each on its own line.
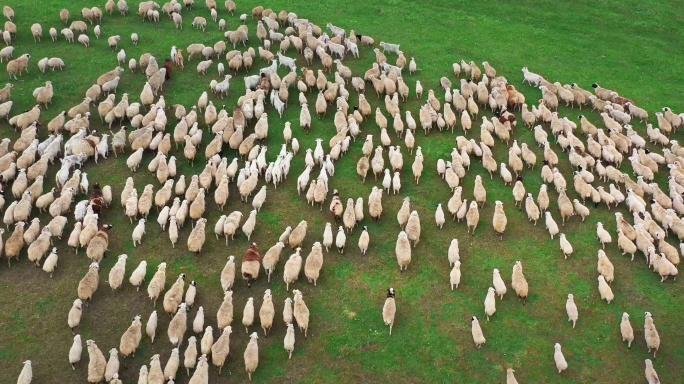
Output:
[0, 0, 684, 384]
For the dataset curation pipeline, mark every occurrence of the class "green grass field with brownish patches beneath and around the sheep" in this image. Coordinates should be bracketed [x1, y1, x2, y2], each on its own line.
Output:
[0, 0, 684, 383]
